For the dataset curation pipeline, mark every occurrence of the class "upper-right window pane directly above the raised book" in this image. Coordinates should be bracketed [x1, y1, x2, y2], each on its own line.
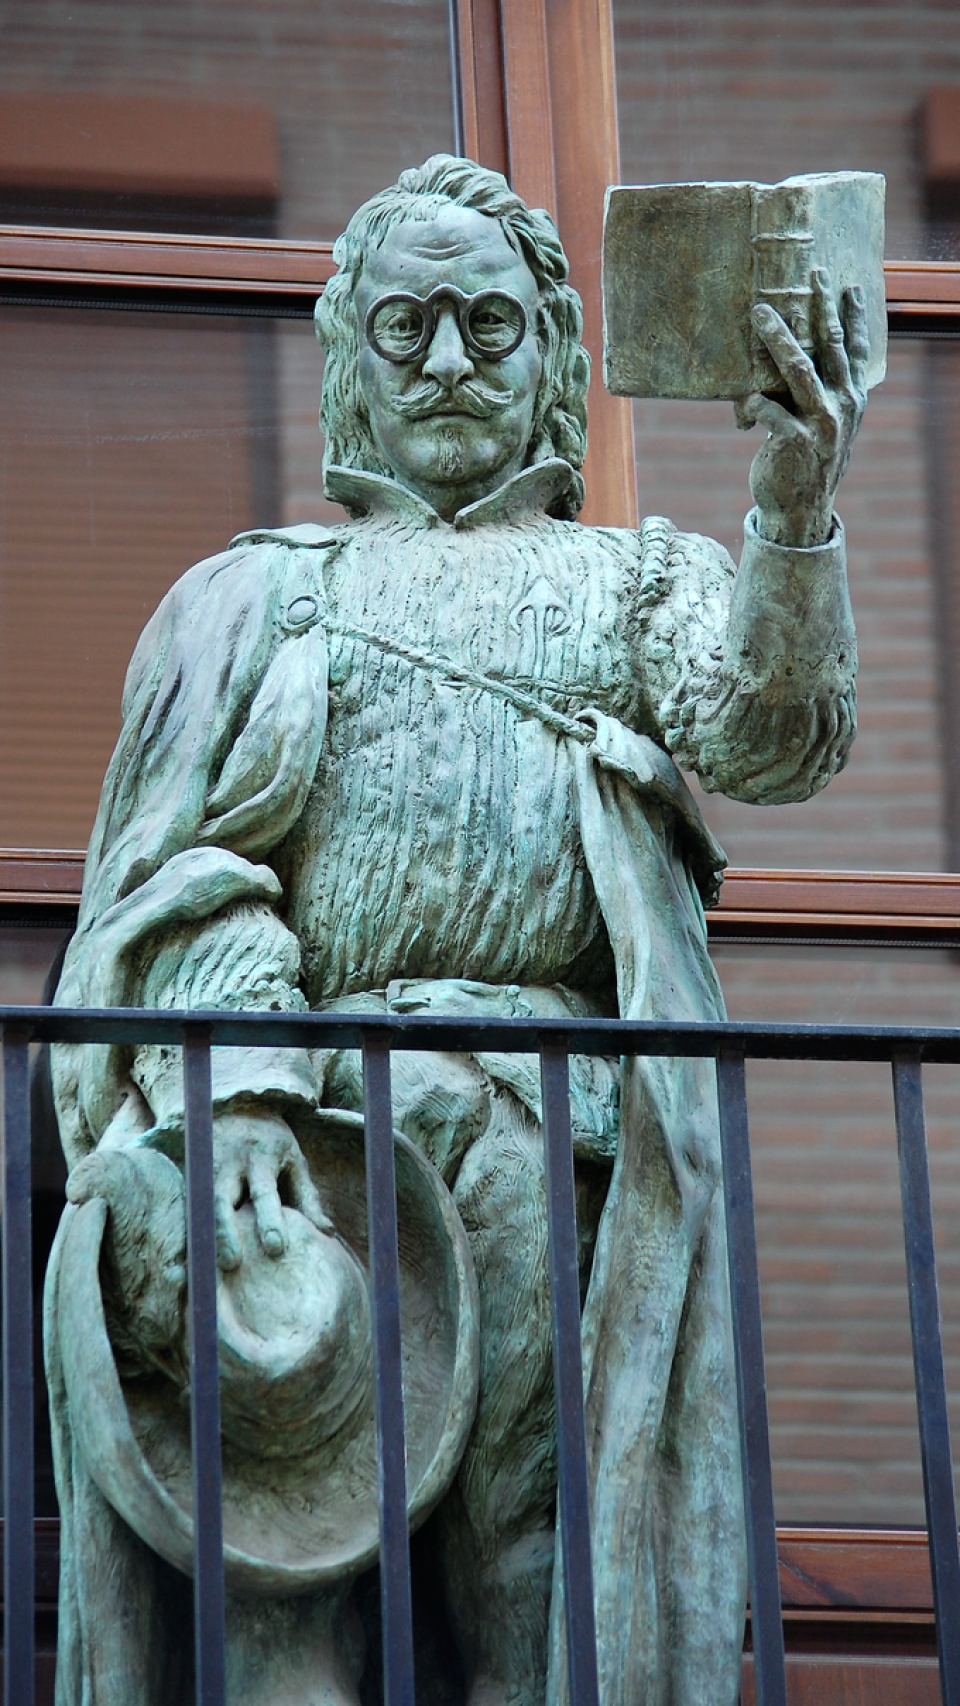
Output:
[614, 0, 960, 259]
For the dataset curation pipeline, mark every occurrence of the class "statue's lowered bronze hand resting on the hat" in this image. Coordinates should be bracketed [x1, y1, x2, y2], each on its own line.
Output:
[213, 1105, 334, 1273]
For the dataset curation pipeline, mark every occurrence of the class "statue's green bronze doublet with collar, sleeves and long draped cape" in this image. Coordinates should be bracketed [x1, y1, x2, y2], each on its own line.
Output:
[55, 461, 854, 1706]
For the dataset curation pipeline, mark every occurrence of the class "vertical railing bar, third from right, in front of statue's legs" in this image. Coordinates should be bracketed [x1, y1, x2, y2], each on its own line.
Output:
[541, 1037, 600, 1706]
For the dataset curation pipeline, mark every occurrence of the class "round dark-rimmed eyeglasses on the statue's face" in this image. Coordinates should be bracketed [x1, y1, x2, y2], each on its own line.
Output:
[363, 285, 527, 362]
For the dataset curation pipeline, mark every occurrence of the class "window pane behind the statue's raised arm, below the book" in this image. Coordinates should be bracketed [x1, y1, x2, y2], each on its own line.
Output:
[634, 339, 960, 870]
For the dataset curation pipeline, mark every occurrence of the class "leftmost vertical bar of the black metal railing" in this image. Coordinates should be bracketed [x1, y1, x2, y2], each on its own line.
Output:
[3, 1027, 34, 1706]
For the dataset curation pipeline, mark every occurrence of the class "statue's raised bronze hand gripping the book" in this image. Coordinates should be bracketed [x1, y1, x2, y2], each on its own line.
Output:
[737, 268, 870, 546]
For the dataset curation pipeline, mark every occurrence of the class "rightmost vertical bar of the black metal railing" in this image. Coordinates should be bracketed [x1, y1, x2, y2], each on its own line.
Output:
[892, 1054, 960, 1706]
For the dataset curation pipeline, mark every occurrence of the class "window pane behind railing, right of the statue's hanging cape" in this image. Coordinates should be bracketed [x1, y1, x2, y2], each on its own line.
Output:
[714, 945, 960, 1525]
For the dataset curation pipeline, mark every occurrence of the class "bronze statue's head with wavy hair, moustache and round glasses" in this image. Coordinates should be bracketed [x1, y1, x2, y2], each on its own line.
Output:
[317, 154, 590, 517]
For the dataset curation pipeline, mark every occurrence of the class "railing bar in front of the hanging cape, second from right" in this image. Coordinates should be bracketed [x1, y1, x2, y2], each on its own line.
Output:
[716, 1049, 786, 1706]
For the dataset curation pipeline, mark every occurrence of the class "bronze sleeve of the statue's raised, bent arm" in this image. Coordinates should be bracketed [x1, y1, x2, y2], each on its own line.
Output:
[639, 512, 856, 805]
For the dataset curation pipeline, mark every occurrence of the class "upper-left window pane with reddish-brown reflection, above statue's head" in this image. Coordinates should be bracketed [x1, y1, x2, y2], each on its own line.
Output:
[0, 0, 454, 239]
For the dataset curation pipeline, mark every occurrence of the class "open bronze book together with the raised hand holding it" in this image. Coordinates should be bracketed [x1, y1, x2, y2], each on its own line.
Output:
[604, 172, 887, 546]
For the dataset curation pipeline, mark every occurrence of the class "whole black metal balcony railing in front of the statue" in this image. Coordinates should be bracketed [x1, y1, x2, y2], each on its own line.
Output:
[0, 1007, 960, 1706]
